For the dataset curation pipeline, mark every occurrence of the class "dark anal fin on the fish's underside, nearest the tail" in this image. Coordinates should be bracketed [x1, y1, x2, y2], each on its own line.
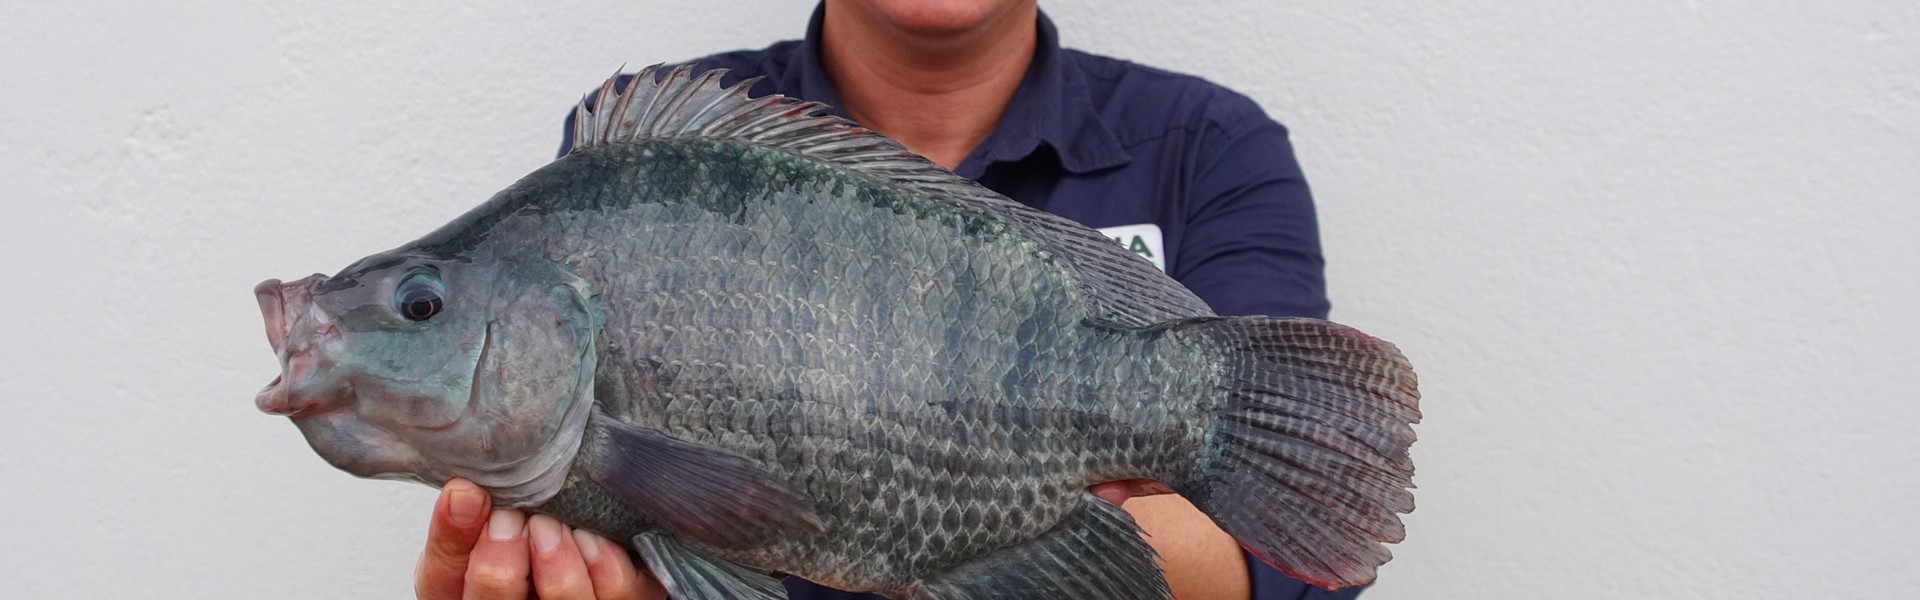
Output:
[904, 494, 1173, 600]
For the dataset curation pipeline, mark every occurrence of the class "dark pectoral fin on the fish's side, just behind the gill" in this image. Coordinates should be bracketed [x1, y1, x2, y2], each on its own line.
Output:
[589, 413, 822, 548]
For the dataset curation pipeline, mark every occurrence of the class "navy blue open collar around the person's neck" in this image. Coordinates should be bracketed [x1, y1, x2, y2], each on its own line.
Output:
[787, 2, 1133, 179]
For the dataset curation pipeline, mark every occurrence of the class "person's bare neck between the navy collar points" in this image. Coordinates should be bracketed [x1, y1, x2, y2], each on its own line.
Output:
[820, 10, 1037, 169]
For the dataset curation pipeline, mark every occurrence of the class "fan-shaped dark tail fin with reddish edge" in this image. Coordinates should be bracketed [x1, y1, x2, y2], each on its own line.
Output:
[1177, 317, 1421, 588]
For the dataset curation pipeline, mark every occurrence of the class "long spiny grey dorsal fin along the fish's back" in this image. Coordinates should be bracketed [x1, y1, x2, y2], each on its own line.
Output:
[572, 65, 1213, 327]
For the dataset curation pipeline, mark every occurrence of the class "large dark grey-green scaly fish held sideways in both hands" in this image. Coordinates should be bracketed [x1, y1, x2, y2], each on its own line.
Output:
[253, 65, 1421, 600]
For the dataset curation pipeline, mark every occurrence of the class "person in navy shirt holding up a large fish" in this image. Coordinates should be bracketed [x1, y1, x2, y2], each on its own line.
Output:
[401, 0, 1397, 600]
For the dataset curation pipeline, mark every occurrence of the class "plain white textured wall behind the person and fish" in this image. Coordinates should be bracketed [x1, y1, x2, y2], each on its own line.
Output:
[0, 0, 1920, 600]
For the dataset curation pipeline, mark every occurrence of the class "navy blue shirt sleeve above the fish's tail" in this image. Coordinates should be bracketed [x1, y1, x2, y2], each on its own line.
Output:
[1169, 94, 1329, 319]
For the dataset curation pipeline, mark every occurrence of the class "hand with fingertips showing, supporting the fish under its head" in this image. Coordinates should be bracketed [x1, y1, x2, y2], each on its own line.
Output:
[413, 479, 666, 600]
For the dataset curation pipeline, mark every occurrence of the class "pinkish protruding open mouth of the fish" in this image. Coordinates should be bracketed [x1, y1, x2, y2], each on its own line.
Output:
[253, 273, 342, 417]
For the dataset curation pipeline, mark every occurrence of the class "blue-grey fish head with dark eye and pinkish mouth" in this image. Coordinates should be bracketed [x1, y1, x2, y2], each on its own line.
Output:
[253, 252, 597, 506]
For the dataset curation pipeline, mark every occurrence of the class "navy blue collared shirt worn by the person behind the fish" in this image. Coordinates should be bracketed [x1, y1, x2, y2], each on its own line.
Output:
[561, 6, 1336, 600]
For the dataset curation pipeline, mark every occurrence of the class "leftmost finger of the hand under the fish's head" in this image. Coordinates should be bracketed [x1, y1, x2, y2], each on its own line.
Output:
[413, 479, 492, 600]
